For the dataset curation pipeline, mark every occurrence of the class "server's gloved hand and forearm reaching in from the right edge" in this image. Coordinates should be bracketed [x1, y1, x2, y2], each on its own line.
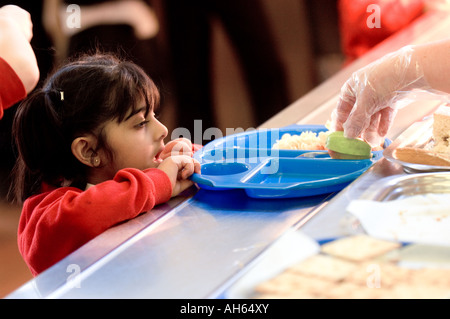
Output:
[332, 39, 450, 146]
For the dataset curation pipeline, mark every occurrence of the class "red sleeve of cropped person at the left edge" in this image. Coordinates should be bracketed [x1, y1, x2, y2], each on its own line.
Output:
[0, 57, 27, 119]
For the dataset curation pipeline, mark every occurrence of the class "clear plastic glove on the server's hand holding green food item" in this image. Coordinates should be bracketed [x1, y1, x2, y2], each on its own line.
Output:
[331, 46, 429, 146]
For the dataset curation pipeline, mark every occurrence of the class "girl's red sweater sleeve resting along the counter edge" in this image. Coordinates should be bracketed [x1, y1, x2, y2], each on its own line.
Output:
[18, 168, 172, 275]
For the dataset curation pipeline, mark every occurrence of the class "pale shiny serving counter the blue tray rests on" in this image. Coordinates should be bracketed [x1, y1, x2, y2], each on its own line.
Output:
[7, 12, 450, 298]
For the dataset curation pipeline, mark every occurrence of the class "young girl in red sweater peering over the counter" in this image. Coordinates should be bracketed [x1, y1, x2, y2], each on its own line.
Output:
[13, 55, 200, 275]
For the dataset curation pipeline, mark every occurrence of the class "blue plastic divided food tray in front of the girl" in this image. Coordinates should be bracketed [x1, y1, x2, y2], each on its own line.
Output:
[191, 125, 388, 198]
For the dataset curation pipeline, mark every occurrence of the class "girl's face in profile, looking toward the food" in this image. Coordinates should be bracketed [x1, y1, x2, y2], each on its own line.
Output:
[104, 107, 168, 178]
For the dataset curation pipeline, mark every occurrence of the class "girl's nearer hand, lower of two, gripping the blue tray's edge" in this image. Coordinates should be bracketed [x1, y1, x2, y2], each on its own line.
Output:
[158, 155, 200, 196]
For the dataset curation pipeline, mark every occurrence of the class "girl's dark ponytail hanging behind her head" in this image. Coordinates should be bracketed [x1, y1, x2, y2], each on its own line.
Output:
[13, 89, 81, 202]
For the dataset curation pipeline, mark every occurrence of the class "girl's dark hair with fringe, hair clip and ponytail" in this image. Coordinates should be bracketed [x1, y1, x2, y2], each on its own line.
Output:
[12, 54, 159, 202]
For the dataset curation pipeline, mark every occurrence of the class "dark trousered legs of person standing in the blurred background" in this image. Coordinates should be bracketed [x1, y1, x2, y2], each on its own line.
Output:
[163, 0, 289, 142]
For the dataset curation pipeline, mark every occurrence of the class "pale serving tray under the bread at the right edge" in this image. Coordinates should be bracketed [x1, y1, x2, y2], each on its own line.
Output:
[383, 116, 450, 173]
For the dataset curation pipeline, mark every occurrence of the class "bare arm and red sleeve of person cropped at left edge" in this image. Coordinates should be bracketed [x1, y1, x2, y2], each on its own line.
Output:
[0, 5, 39, 119]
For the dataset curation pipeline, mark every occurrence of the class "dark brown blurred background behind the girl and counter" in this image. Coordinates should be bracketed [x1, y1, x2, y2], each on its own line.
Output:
[0, 0, 428, 297]
